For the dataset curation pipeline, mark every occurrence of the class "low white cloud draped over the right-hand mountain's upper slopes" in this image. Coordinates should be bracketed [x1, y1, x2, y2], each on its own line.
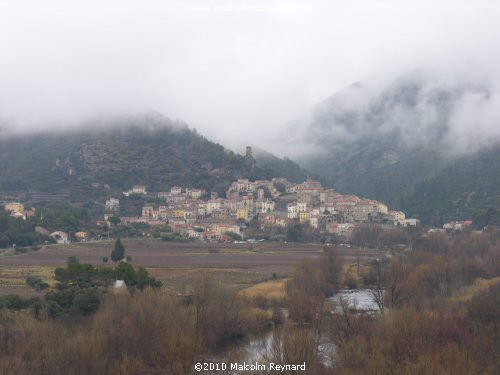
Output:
[283, 70, 500, 158]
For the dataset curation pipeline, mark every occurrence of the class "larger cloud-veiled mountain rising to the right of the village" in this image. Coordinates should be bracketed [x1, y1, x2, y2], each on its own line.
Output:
[285, 71, 500, 224]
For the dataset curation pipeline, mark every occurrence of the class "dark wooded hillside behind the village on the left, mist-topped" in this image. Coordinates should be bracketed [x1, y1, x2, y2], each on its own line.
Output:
[0, 115, 302, 201]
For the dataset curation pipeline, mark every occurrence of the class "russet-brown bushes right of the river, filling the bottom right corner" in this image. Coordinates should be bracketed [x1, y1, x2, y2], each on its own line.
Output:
[334, 232, 500, 374]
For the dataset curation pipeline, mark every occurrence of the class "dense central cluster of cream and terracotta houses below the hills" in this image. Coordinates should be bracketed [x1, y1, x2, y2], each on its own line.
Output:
[104, 178, 418, 241]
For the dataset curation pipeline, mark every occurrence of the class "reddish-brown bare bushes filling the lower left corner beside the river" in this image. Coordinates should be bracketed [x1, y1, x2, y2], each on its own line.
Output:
[0, 275, 269, 375]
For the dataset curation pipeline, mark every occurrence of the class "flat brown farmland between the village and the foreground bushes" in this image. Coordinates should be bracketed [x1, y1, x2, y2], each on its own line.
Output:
[0, 239, 381, 295]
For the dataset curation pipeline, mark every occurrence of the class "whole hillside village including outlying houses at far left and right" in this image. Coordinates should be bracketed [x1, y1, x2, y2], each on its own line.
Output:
[0, 170, 472, 248]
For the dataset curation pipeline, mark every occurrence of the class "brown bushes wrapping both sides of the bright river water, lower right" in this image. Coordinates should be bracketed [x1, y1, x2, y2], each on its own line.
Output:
[278, 231, 500, 375]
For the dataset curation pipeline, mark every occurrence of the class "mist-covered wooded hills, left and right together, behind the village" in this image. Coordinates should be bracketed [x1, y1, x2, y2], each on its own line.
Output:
[0, 71, 500, 225]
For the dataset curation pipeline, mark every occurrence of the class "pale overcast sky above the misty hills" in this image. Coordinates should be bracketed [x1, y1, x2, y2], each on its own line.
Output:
[0, 0, 500, 153]
